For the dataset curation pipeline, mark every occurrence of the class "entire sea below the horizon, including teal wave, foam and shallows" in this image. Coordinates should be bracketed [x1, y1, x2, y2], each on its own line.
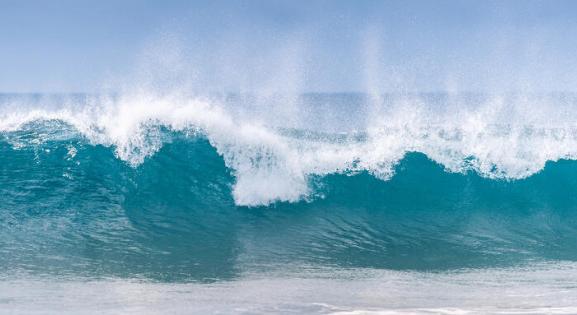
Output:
[0, 91, 577, 314]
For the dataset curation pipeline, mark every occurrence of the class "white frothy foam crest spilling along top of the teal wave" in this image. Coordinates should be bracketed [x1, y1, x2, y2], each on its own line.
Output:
[0, 92, 577, 206]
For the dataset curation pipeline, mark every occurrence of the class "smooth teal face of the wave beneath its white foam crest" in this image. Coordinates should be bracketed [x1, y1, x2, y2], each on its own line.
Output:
[5, 130, 577, 281]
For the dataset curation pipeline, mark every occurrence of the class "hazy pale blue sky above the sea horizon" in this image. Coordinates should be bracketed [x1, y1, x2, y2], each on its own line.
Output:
[0, 0, 577, 92]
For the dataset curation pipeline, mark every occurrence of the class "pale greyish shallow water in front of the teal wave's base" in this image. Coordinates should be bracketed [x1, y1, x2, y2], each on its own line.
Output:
[0, 263, 577, 314]
